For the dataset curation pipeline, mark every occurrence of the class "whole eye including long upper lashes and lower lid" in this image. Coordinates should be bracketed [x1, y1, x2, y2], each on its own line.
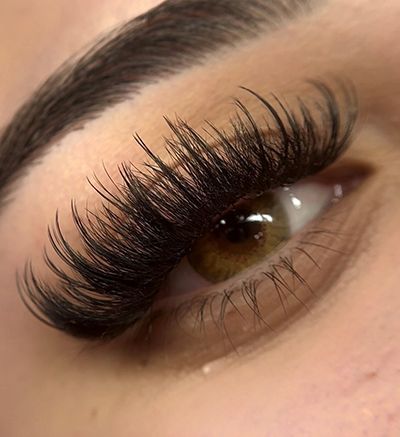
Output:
[15, 82, 367, 362]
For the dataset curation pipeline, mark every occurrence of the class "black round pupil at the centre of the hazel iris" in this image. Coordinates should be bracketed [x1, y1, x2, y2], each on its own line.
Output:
[214, 210, 263, 244]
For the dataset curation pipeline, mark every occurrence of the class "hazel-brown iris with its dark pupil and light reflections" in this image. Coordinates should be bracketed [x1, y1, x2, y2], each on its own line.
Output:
[188, 193, 291, 283]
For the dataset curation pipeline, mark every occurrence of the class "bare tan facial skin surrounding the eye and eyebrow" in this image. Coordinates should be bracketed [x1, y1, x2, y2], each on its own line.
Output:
[0, 0, 400, 437]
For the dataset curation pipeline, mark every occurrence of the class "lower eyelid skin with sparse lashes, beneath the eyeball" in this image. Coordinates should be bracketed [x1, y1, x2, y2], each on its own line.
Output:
[129, 169, 376, 366]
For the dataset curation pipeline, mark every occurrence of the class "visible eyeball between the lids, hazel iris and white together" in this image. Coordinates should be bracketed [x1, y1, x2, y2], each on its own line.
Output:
[168, 178, 345, 294]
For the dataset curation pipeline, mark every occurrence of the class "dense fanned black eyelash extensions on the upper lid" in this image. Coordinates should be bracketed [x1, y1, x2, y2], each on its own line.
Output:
[17, 82, 357, 339]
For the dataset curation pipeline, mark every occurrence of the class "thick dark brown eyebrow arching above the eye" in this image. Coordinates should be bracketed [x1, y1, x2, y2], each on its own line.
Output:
[0, 0, 310, 202]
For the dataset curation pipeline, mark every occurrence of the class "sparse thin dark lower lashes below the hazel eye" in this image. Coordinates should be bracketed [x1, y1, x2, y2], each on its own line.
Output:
[140, 204, 359, 359]
